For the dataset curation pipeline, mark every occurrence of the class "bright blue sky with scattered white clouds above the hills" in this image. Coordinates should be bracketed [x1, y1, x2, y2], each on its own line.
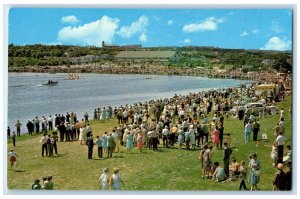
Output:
[8, 7, 293, 50]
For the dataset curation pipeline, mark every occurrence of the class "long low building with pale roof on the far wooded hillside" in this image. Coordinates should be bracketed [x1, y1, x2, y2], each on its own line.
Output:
[115, 51, 180, 62]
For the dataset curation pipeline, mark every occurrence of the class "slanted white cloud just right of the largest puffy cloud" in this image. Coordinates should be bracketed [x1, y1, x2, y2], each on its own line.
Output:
[117, 15, 148, 38]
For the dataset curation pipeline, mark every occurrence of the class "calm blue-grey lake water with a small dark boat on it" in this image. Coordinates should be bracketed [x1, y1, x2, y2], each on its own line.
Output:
[8, 73, 250, 133]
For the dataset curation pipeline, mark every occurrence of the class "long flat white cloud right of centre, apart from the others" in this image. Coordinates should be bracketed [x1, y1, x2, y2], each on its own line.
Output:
[182, 17, 224, 33]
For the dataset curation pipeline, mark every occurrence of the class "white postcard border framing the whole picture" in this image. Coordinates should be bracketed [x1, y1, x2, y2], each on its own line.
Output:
[0, 0, 300, 199]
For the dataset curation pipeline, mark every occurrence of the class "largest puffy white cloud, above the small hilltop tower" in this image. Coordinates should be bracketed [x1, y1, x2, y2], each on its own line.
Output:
[58, 16, 119, 46]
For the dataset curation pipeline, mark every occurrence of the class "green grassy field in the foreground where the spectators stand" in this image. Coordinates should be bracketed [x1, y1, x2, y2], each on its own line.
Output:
[7, 96, 292, 191]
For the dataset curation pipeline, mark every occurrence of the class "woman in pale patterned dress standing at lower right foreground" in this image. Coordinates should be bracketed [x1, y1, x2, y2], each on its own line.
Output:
[249, 154, 260, 191]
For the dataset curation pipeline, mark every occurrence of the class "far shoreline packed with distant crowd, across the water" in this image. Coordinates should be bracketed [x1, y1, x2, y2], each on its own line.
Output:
[8, 64, 257, 80]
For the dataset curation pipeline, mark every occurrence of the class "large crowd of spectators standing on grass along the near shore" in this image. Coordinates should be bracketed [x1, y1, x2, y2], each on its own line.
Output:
[8, 70, 291, 190]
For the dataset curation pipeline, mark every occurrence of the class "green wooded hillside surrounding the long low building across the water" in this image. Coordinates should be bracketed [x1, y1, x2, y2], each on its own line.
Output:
[8, 44, 292, 72]
